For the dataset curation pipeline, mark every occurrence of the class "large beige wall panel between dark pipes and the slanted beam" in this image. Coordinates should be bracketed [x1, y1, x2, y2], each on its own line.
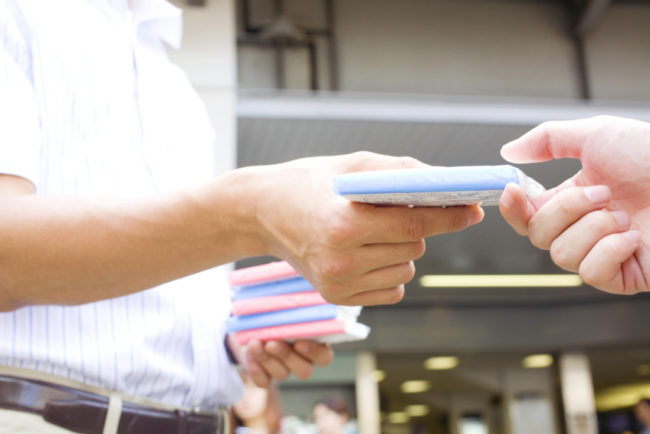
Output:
[337, 0, 577, 98]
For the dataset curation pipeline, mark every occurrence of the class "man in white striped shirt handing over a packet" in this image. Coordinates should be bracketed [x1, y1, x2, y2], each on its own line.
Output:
[0, 0, 476, 434]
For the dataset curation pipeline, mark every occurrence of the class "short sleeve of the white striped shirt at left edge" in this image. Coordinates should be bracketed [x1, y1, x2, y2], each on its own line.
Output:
[0, 2, 41, 186]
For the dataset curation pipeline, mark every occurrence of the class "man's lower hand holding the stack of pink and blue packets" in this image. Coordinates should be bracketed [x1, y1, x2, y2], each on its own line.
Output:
[228, 339, 334, 387]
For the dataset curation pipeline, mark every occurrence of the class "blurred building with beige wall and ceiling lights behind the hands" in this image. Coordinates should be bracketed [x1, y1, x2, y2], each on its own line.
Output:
[170, 0, 650, 434]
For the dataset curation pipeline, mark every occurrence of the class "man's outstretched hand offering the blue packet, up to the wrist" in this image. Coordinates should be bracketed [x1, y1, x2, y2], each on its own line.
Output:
[246, 152, 483, 305]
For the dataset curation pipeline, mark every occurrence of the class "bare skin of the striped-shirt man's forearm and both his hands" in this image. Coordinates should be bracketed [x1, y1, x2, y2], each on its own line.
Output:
[0, 152, 483, 386]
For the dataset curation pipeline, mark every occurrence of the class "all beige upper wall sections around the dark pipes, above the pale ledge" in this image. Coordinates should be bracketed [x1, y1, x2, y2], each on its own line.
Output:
[238, 0, 650, 101]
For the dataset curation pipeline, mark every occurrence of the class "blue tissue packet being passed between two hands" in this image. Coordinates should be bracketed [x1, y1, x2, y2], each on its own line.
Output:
[334, 165, 545, 206]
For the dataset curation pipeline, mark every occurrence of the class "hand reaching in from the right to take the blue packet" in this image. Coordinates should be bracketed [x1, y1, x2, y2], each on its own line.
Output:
[499, 116, 650, 294]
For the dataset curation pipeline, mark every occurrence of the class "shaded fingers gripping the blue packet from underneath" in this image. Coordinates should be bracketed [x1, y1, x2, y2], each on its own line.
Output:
[311, 204, 484, 305]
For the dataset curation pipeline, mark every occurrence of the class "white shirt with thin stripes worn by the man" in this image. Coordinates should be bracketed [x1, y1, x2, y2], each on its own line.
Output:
[0, 0, 243, 408]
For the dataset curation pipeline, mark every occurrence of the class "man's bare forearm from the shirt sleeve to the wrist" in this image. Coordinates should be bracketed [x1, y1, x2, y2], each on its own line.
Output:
[0, 171, 265, 310]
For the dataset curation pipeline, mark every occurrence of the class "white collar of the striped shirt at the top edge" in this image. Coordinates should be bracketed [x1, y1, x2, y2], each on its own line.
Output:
[129, 0, 183, 49]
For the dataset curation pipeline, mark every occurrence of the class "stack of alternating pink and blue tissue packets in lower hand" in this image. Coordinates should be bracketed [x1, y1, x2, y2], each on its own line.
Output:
[226, 261, 370, 345]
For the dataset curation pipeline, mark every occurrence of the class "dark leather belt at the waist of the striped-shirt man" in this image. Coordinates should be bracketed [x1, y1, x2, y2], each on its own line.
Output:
[0, 375, 228, 434]
